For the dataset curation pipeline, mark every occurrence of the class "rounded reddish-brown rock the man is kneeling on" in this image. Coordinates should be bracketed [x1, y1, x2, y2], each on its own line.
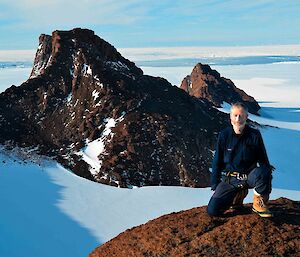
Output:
[89, 198, 300, 257]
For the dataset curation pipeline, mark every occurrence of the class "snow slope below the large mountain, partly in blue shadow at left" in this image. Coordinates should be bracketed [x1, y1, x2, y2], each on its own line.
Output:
[0, 148, 300, 257]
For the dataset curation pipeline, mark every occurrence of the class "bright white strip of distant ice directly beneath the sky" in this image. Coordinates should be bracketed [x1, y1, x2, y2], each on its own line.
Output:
[0, 43, 300, 62]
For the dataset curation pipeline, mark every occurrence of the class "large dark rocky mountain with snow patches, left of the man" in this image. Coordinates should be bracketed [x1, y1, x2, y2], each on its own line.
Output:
[0, 28, 228, 187]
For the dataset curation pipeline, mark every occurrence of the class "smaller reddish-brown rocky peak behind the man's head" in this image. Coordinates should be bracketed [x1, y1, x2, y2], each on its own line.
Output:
[180, 63, 260, 115]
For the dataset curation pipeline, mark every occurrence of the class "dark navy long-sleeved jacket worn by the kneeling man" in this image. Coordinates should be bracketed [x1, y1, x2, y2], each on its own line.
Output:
[211, 125, 270, 187]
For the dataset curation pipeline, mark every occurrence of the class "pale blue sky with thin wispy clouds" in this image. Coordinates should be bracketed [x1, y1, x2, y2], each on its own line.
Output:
[0, 0, 300, 50]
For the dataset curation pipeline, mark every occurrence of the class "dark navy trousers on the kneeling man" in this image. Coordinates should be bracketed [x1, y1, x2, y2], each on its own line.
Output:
[207, 167, 272, 216]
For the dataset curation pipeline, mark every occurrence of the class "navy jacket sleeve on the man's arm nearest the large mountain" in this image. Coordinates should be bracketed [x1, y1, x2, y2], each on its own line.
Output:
[211, 133, 224, 190]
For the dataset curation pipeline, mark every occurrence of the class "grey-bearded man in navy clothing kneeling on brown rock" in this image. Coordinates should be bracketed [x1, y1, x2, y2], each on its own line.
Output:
[207, 103, 274, 217]
